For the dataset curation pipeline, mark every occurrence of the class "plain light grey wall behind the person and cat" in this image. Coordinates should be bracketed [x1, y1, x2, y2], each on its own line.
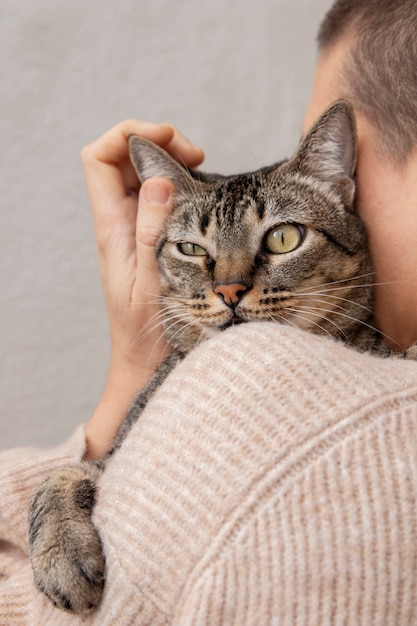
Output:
[0, 0, 331, 448]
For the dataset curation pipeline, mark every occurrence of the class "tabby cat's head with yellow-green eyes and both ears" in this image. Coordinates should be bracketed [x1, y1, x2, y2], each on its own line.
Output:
[129, 101, 372, 353]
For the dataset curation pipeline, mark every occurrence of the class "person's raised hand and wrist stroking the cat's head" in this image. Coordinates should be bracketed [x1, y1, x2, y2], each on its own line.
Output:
[81, 120, 204, 458]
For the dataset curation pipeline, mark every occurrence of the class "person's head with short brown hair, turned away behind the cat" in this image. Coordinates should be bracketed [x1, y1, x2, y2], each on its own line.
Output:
[304, 0, 417, 346]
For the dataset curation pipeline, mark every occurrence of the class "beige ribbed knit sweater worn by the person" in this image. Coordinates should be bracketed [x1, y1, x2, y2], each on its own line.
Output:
[0, 323, 417, 626]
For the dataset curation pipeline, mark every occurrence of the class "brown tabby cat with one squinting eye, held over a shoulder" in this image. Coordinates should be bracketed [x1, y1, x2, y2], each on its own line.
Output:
[29, 101, 404, 614]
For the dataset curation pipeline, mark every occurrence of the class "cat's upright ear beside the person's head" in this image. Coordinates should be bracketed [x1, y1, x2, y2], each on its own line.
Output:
[294, 100, 357, 205]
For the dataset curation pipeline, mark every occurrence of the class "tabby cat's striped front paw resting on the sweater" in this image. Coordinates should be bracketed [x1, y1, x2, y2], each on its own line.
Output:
[29, 463, 104, 614]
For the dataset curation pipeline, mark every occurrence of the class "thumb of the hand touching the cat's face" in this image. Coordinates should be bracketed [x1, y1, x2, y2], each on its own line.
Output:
[136, 177, 175, 294]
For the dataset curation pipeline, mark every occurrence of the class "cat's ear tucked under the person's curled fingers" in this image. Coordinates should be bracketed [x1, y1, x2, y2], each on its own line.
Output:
[129, 135, 191, 191]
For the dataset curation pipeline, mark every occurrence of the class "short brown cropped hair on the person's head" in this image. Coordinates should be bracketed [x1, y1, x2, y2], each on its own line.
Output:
[317, 0, 417, 164]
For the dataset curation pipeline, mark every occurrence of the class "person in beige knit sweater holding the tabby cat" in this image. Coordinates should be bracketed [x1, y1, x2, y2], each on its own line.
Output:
[0, 0, 417, 626]
